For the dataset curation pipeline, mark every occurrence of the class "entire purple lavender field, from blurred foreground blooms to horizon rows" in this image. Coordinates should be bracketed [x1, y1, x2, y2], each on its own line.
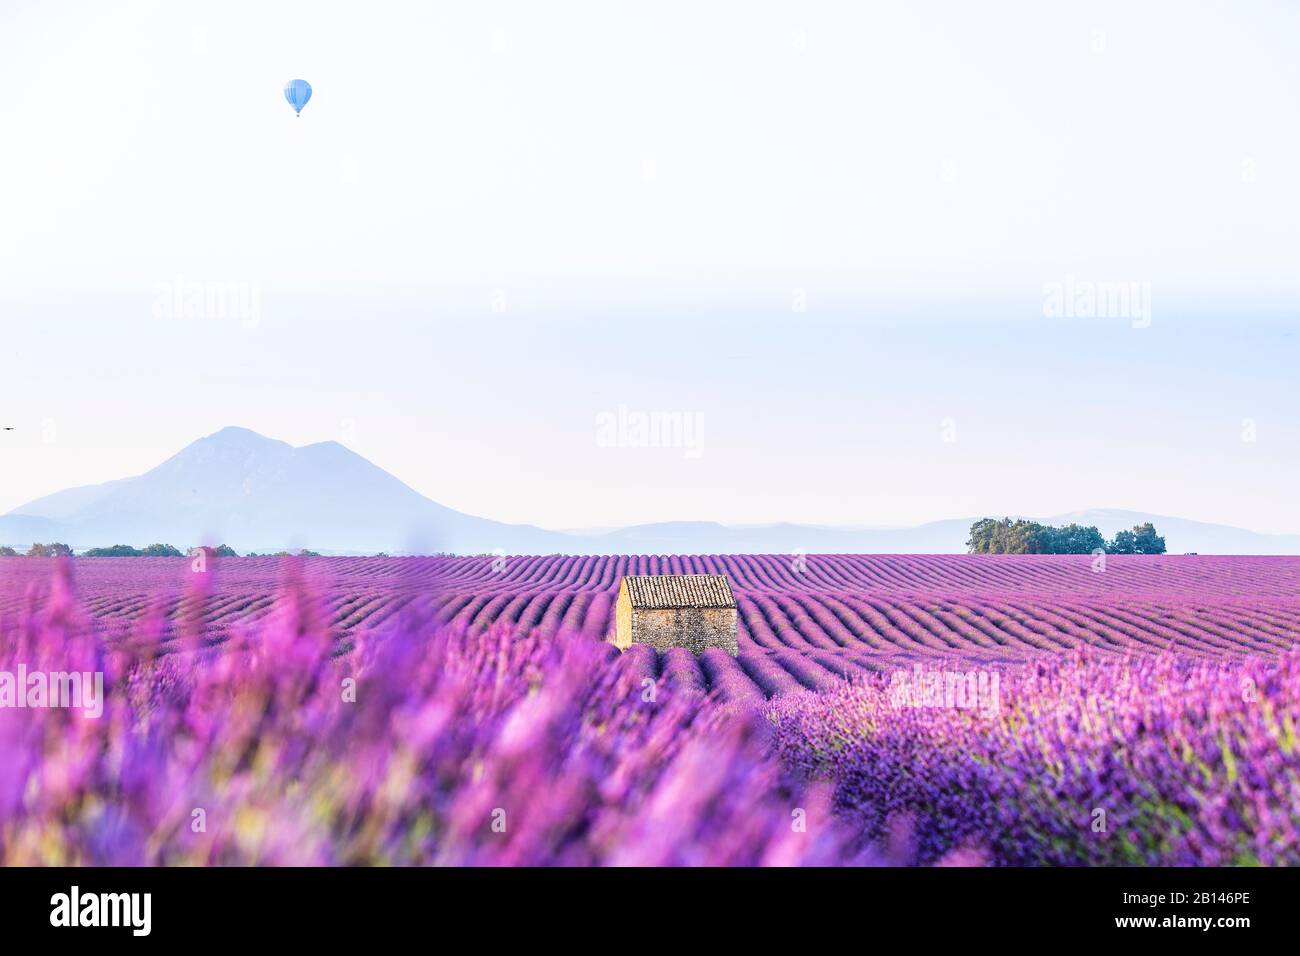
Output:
[0, 555, 1300, 865]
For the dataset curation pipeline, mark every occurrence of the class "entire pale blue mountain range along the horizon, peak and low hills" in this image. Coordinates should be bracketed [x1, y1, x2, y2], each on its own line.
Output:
[0, 428, 1300, 554]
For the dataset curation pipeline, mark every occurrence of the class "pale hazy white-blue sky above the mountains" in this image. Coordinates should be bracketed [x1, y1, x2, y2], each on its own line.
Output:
[0, 0, 1300, 532]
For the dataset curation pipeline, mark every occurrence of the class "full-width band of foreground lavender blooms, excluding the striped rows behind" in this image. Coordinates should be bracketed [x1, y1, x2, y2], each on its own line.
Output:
[0, 561, 1300, 865]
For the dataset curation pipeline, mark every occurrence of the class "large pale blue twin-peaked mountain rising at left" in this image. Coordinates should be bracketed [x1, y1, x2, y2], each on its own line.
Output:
[0, 428, 564, 553]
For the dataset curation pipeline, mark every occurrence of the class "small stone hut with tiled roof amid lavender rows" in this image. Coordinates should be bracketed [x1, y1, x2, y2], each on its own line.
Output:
[612, 575, 737, 657]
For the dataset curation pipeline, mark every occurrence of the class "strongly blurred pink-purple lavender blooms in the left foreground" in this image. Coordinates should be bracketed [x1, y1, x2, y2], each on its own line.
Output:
[0, 564, 863, 865]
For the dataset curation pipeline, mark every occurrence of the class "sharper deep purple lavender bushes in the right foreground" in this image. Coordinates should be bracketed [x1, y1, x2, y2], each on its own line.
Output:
[767, 650, 1300, 865]
